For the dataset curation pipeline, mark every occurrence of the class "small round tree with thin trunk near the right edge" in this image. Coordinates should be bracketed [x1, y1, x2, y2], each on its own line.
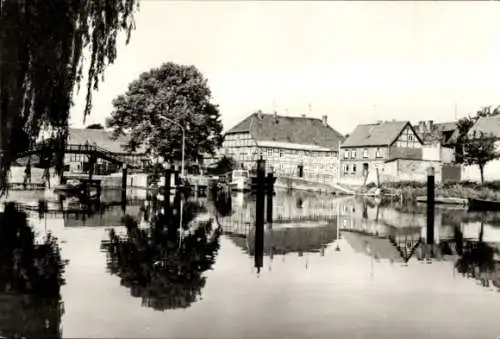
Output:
[463, 134, 499, 184]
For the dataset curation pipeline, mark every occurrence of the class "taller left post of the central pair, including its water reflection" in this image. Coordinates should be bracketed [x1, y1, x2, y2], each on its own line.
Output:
[254, 158, 266, 272]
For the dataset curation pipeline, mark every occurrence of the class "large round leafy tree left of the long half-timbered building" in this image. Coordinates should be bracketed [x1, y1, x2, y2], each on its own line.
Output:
[107, 62, 222, 165]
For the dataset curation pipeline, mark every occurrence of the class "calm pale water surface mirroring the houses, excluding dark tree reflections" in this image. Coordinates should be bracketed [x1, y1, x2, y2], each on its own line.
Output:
[0, 192, 500, 338]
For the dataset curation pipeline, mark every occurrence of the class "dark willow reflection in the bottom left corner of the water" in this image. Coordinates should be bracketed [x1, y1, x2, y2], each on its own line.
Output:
[0, 203, 65, 338]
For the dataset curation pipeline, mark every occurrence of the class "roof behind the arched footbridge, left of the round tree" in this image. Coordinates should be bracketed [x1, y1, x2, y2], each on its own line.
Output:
[68, 128, 143, 153]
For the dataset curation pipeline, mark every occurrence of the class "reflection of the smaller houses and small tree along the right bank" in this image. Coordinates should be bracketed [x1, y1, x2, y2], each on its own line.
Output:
[339, 200, 500, 290]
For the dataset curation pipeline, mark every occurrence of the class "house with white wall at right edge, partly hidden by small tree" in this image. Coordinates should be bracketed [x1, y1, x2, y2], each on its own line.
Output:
[462, 115, 500, 181]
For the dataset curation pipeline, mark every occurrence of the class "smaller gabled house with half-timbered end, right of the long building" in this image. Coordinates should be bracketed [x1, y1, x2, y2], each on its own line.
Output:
[340, 121, 423, 183]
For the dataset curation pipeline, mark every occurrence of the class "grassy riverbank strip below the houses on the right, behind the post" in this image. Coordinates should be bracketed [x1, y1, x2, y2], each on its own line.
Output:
[382, 181, 500, 201]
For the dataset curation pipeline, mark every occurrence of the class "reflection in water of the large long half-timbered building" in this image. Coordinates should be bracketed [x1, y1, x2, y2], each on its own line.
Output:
[218, 191, 345, 271]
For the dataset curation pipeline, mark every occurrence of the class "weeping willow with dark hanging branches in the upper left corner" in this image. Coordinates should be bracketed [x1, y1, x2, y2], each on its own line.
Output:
[0, 0, 138, 195]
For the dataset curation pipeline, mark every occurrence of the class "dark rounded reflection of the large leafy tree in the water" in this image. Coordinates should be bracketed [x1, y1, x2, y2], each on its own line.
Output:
[102, 202, 220, 311]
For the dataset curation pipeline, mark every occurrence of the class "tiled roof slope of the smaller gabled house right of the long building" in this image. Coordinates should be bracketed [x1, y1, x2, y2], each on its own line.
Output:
[342, 121, 409, 147]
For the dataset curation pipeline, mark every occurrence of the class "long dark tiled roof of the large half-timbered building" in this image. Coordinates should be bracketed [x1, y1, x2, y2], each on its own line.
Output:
[226, 113, 344, 150]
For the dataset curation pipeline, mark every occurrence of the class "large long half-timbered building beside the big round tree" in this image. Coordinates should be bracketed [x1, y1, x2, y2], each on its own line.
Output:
[221, 111, 344, 181]
